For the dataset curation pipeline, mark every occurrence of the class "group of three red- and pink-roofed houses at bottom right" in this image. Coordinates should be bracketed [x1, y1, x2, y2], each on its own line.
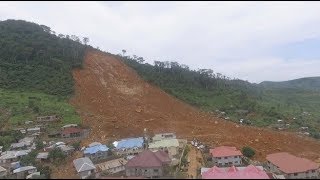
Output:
[201, 146, 319, 179]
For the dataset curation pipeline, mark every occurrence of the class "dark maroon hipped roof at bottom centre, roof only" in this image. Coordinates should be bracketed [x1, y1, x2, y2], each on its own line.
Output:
[125, 150, 170, 167]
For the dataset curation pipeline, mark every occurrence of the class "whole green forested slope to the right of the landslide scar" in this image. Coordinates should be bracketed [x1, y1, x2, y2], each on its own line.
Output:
[116, 55, 320, 137]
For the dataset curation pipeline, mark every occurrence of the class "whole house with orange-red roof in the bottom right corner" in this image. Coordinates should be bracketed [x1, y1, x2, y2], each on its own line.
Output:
[266, 152, 319, 179]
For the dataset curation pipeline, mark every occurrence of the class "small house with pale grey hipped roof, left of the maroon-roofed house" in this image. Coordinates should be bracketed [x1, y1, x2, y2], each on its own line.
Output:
[73, 157, 96, 179]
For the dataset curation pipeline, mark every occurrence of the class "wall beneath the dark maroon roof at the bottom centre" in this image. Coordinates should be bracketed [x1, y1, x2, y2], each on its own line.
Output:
[126, 167, 163, 178]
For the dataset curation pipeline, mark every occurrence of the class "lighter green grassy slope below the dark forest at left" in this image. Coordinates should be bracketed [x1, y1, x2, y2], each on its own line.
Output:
[0, 89, 81, 127]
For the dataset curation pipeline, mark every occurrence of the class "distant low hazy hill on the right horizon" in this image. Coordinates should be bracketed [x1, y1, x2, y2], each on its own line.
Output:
[259, 77, 320, 91]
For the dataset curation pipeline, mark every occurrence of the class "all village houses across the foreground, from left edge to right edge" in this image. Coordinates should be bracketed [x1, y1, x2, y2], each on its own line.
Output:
[0, 113, 319, 179]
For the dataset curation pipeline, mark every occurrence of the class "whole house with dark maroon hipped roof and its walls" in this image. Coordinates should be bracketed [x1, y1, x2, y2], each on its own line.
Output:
[125, 150, 171, 178]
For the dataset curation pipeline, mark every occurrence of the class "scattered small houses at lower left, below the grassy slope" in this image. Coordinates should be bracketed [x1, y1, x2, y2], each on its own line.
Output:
[0, 116, 88, 179]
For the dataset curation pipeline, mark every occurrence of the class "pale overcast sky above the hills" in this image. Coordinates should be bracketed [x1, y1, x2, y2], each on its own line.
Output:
[0, 1, 320, 83]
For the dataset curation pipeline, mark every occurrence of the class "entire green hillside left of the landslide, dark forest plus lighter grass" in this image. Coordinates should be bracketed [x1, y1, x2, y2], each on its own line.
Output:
[0, 20, 89, 131]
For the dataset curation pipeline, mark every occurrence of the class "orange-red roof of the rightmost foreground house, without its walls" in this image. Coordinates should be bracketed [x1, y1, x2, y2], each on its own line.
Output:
[266, 152, 319, 174]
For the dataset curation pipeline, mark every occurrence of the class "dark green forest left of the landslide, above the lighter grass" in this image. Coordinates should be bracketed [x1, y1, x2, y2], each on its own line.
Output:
[0, 20, 85, 96]
